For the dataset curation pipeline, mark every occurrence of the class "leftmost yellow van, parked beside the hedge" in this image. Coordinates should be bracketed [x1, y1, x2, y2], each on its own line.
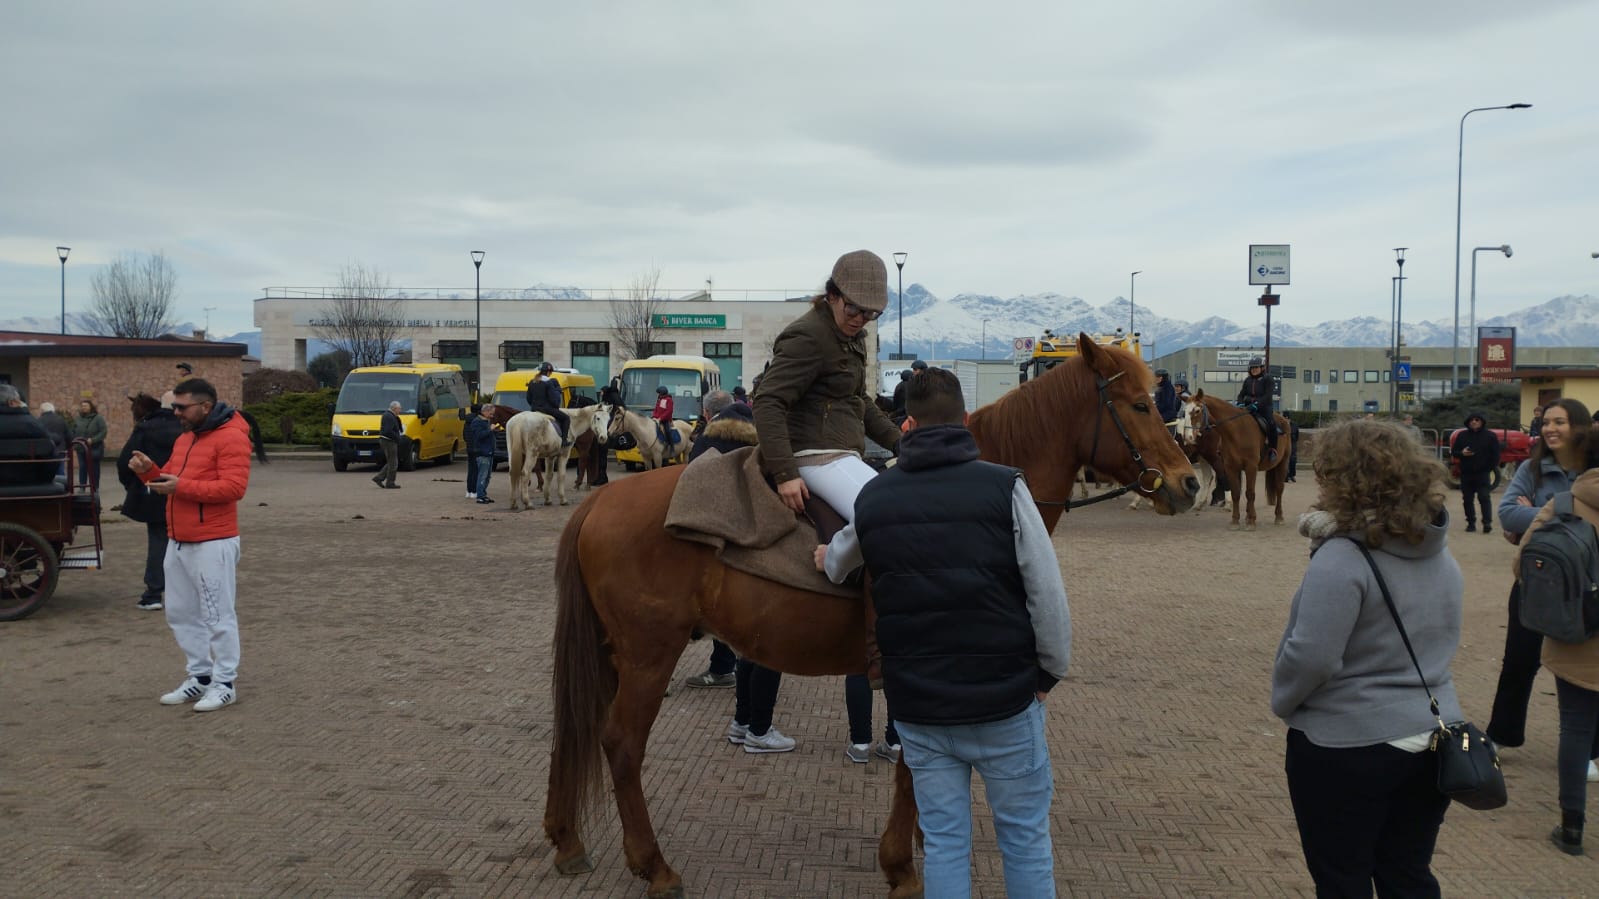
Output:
[333, 363, 470, 472]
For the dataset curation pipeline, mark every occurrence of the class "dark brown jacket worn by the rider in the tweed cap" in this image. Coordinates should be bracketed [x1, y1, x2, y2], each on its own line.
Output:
[755, 304, 900, 483]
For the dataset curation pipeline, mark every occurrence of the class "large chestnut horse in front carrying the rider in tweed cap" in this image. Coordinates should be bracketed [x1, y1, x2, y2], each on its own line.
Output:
[544, 336, 1198, 899]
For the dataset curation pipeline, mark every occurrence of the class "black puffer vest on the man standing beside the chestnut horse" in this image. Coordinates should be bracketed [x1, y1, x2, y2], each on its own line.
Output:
[855, 426, 1038, 725]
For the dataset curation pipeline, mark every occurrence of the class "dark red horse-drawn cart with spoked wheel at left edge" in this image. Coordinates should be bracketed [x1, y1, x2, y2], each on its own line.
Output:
[0, 440, 104, 621]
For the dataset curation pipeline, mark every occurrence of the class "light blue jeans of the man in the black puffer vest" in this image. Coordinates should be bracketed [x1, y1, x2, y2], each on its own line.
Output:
[895, 701, 1055, 899]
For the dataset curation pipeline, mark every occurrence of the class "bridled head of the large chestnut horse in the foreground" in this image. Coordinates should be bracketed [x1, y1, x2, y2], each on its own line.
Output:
[1074, 333, 1199, 515]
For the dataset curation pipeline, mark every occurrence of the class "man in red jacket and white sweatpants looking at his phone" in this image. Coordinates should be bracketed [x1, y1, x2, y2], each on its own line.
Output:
[128, 378, 249, 712]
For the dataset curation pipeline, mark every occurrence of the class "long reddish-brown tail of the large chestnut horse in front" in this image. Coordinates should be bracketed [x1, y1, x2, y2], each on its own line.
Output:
[544, 493, 617, 830]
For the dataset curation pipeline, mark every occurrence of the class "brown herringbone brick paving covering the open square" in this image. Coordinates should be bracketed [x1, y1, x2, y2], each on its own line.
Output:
[0, 459, 1599, 897]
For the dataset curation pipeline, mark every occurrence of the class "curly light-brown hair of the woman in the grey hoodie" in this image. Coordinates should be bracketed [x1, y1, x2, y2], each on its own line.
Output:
[1311, 419, 1445, 549]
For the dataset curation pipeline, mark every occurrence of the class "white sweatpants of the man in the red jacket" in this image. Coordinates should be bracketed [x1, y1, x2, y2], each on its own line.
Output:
[163, 537, 238, 683]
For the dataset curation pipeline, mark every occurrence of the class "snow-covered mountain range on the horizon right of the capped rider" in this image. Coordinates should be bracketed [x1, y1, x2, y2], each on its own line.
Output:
[878, 285, 1599, 358]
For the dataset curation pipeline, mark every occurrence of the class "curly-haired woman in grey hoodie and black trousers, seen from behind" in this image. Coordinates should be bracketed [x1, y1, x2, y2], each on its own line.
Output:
[1271, 421, 1465, 896]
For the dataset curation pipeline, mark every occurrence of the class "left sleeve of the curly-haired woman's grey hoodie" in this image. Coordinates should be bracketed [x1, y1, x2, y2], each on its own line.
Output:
[1271, 541, 1366, 718]
